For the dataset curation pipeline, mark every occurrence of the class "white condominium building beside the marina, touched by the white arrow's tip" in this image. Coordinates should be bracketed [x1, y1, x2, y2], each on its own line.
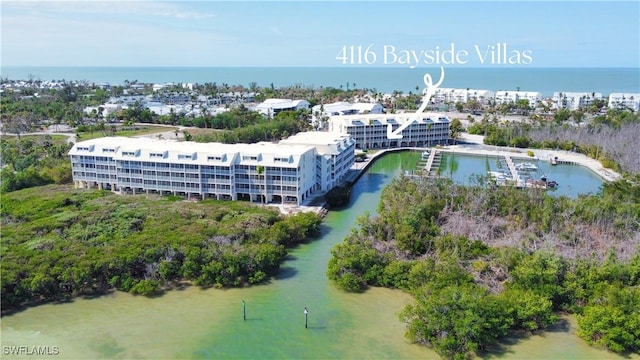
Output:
[329, 113, 451, 149]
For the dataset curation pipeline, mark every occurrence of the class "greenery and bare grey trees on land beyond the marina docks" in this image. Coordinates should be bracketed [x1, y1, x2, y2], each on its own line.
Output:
[468, 109, 640, 174]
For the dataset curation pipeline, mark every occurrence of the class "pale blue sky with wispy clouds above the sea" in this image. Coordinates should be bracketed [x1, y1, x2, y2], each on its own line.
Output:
[0, 0, 640, 67]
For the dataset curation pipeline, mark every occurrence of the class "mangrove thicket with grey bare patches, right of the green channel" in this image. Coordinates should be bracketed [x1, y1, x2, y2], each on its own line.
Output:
[327, 177, 640, 359]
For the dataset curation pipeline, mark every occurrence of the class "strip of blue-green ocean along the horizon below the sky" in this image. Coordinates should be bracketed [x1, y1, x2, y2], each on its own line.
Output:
[0, 66, 640, 97]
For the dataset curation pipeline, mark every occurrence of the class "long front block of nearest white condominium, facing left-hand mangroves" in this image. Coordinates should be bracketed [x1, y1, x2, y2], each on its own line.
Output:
[69, 134, 354, 205]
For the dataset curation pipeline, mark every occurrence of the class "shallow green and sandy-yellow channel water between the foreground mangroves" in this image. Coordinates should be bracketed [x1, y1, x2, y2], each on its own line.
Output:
[1, 153, 637, 359]
